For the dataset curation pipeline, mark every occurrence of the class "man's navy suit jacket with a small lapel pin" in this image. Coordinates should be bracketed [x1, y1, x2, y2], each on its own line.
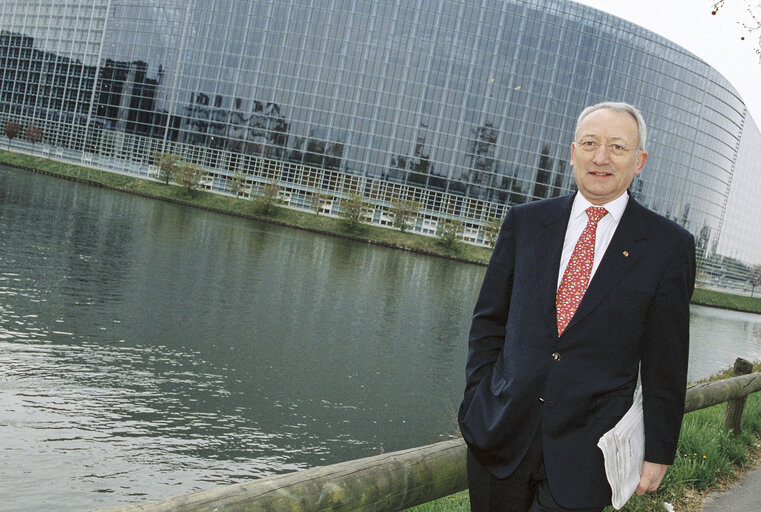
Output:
[458, 195, 695, 508]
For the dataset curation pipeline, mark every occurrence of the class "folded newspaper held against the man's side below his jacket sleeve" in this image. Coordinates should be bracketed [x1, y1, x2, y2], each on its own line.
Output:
[597, 387, 645, 510]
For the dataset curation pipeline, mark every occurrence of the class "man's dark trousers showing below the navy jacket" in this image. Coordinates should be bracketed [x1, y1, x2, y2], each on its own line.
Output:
[467, 429, 602, 512]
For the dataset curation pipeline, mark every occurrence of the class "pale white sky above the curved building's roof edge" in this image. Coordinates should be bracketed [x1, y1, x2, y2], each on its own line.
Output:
[575, 0, 761, 127]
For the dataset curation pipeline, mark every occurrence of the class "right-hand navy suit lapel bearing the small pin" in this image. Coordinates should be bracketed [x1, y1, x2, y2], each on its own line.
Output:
[566, 198, 646, 329]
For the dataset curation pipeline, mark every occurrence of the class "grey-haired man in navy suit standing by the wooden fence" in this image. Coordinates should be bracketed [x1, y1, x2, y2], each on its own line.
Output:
[458, 103, 695, 512]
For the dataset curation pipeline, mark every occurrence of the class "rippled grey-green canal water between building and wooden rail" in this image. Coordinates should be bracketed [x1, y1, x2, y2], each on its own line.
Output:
[0, 167, 761, 510]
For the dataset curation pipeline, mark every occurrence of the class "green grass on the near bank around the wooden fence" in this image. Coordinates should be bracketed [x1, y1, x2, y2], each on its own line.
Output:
[408, 364, 761, 512]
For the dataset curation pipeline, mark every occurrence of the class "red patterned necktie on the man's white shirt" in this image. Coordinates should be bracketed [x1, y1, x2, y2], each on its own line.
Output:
[557, 206, 608, 336]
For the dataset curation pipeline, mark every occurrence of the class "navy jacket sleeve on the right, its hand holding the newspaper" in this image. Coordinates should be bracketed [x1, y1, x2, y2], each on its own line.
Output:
[640, 233, 695, 465]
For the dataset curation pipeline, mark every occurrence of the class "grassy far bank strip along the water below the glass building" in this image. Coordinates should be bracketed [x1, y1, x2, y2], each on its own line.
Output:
[0, 150, 761, 313]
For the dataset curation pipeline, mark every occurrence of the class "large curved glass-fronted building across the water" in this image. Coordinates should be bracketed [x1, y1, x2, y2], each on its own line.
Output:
[0, 0, 761, 289]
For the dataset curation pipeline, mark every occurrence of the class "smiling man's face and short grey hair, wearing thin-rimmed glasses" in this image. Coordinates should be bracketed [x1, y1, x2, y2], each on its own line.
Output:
[571, 108, 647, 205]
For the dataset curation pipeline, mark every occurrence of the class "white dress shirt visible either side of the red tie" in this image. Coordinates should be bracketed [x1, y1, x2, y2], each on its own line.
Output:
[557, 192, 629, 288]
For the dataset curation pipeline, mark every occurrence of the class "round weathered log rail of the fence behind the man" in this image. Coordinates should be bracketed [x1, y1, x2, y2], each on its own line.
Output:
[105, 363, 761, 512]
